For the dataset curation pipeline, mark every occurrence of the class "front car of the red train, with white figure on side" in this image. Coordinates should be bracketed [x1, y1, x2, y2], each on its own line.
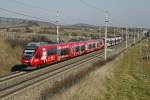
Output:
[21, 42, 58, 69]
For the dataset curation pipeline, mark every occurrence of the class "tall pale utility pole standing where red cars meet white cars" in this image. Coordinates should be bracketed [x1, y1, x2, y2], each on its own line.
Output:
[104, 12, 109, 60]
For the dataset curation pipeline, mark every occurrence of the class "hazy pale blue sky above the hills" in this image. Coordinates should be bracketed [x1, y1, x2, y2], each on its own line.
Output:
[0, 0, 150, 27]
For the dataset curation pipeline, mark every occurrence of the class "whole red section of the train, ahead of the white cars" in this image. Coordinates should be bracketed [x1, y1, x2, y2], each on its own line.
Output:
[21, 39, 104, 69]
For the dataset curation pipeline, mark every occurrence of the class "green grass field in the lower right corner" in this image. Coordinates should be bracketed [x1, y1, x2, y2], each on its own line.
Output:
[102, 41, 150, 100]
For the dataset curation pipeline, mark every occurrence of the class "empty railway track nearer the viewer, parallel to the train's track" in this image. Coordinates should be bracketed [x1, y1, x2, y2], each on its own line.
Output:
[0, 50, 103, 97]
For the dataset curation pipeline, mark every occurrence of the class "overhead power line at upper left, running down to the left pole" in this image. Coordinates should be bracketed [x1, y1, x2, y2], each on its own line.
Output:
[0, 8, 54, 23]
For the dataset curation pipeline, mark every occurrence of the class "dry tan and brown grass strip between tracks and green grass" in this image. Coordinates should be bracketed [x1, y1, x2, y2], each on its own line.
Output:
[41, 53, 121, 100]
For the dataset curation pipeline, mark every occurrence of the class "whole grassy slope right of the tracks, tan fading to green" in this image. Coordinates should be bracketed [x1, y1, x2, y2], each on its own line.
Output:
[49, 40, 150, 100]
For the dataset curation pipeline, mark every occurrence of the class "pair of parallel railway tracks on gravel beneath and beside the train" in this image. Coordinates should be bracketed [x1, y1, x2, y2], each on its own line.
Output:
[0, 41, 130, 98]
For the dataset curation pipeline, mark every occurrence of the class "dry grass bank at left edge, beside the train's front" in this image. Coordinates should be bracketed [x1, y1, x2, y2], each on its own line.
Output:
[0, 38, 22, 75]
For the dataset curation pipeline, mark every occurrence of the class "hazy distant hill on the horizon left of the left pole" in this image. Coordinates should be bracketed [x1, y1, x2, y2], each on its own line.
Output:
[0, 17, 55, 28]
